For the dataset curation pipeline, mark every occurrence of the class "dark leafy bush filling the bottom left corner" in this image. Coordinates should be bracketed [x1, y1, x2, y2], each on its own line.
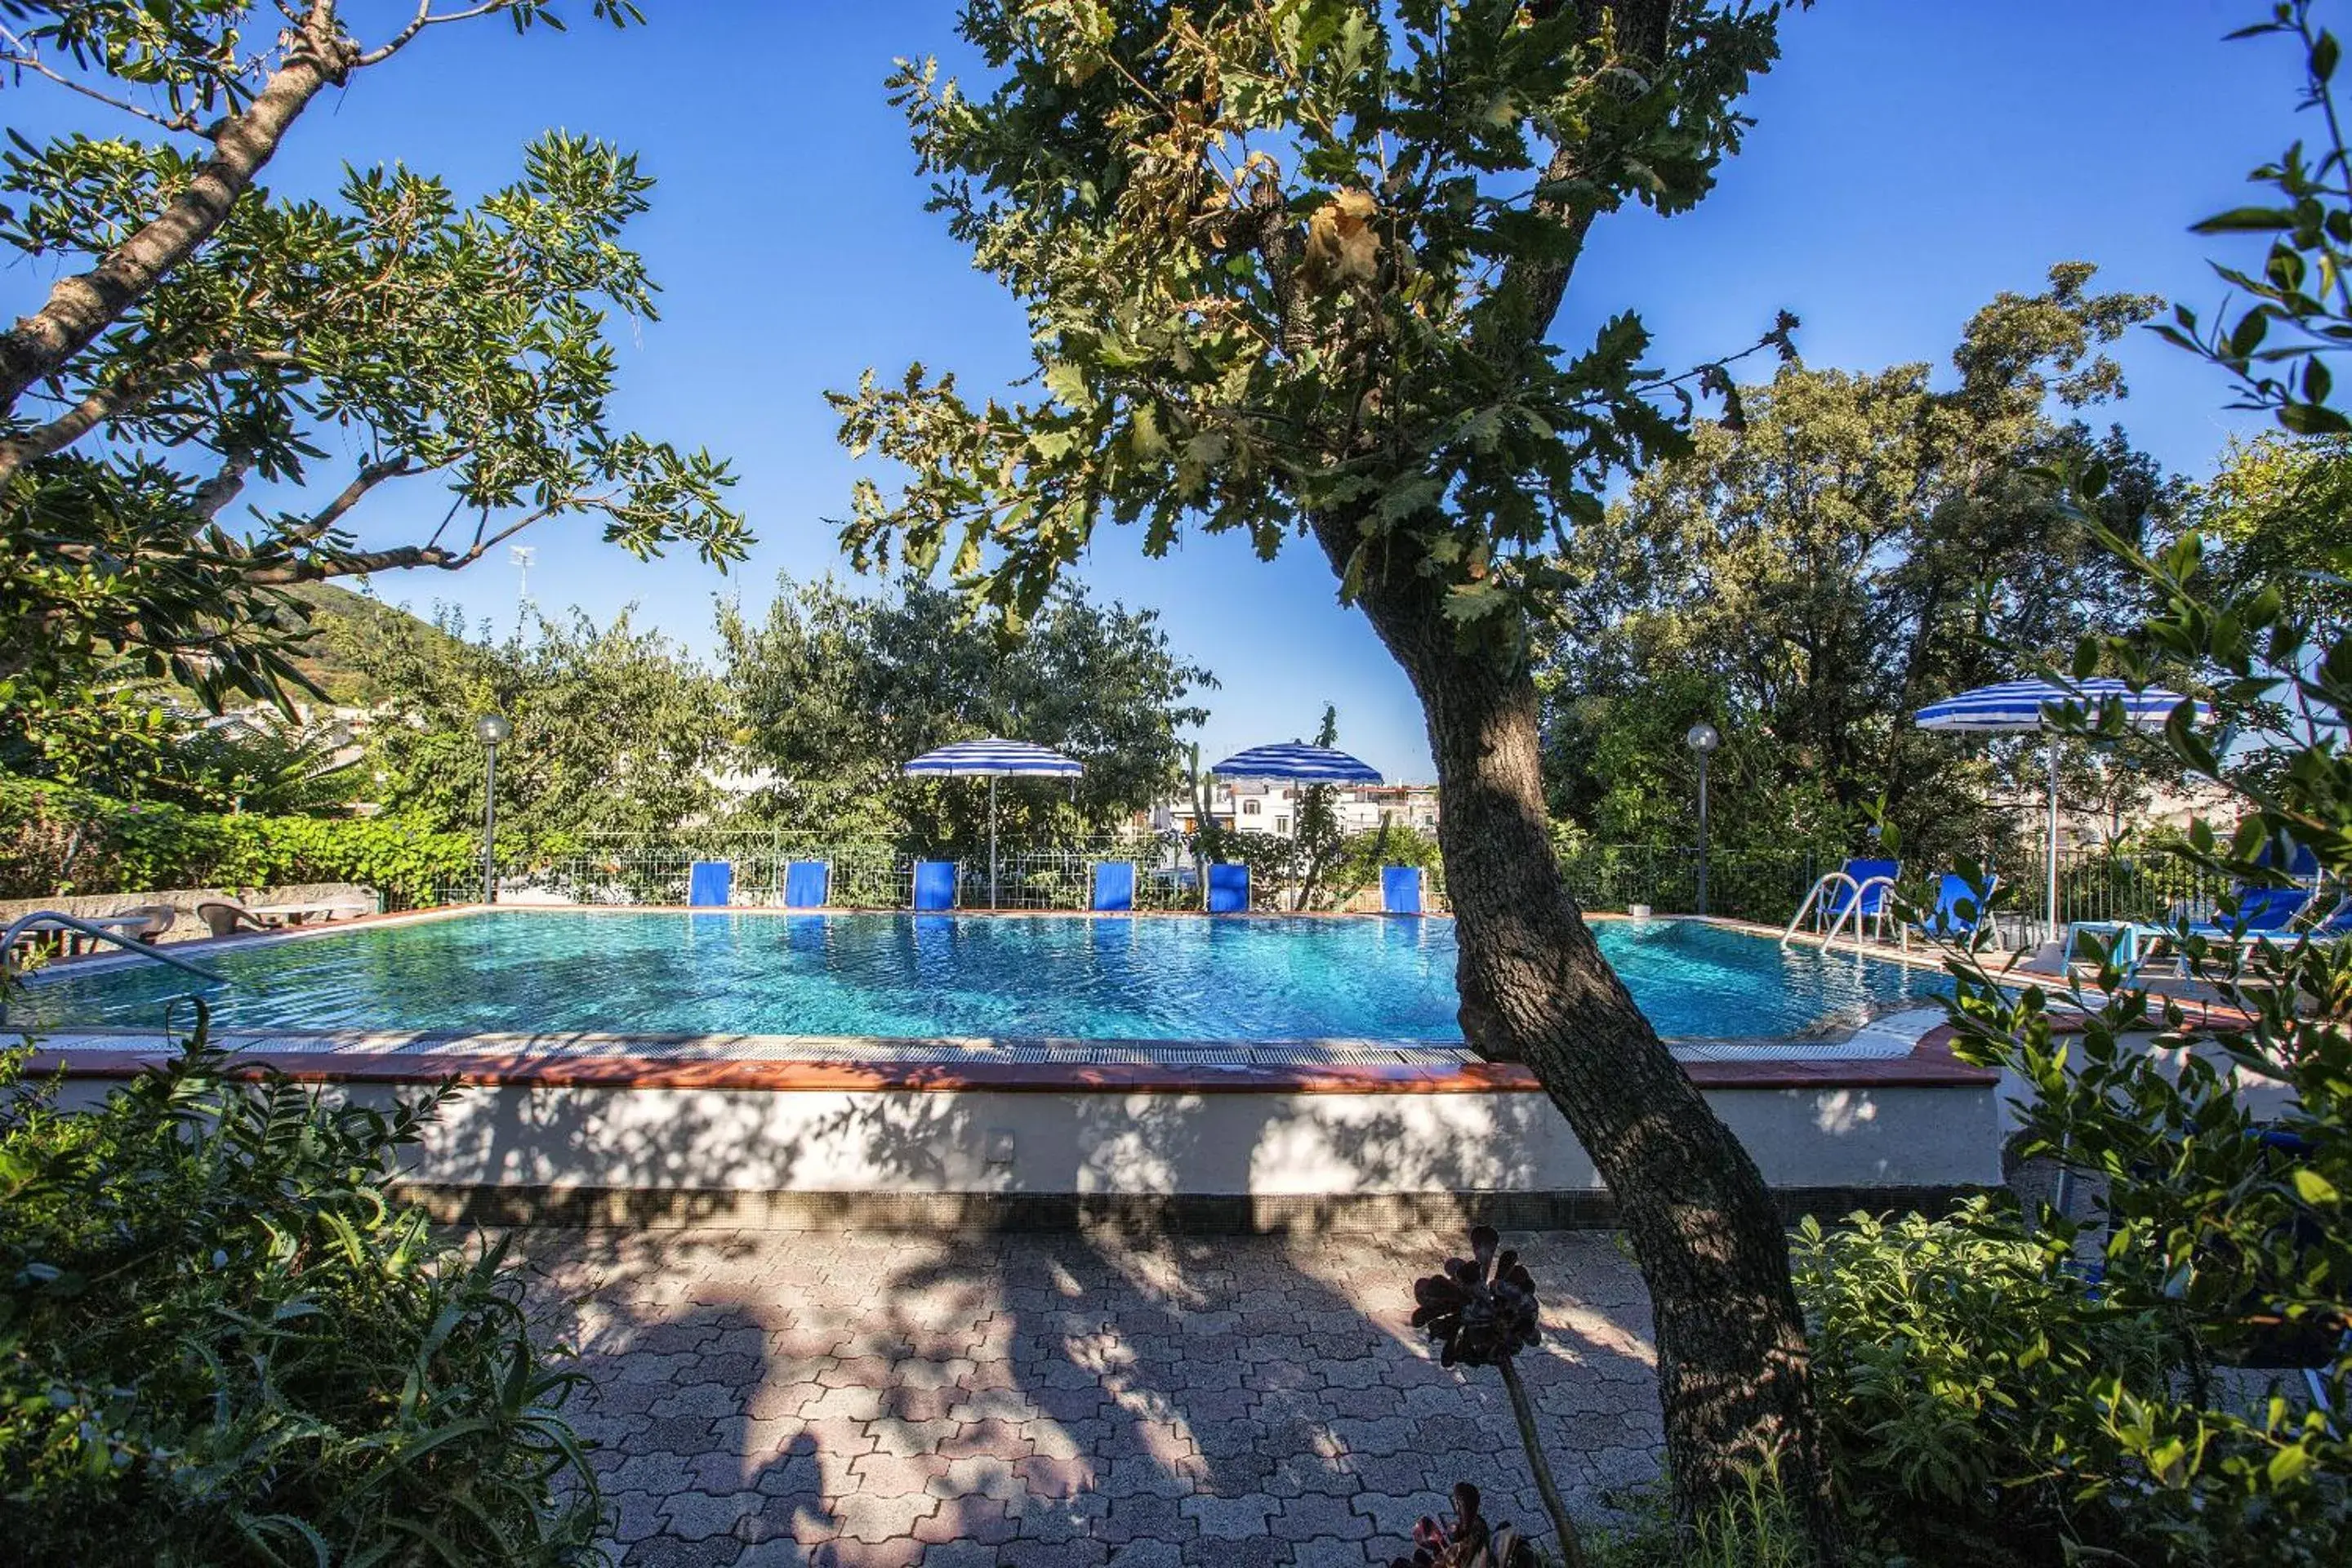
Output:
[0, 1041, 602, 1566]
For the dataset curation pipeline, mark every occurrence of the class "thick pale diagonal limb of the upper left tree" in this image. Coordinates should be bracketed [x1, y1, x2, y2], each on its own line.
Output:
[0, 2, 358, 430]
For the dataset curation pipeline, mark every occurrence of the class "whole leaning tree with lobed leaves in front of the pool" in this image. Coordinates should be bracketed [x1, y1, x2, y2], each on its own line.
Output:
[835, 0, 1834, 1549]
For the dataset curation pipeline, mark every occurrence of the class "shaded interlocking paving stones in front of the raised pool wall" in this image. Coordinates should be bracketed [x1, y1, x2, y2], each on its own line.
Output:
[518, 1229, 1660, 1568]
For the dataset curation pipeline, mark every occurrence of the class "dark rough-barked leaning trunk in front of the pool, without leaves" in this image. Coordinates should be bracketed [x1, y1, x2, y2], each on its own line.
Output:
[1326, 523, 1837, 1558]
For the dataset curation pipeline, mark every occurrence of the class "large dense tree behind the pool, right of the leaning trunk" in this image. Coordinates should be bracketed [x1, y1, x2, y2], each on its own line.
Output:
[1545, 263, 2180, 856]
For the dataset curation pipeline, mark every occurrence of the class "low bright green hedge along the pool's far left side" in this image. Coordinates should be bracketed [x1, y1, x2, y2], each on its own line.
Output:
[0, 778, 482, 905]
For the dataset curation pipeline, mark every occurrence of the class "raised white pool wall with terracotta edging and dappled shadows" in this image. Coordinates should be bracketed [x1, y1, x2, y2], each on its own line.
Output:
[18, 912, 2002, 1232]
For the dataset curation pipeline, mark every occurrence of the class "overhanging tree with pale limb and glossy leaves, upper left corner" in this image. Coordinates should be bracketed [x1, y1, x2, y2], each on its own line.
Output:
[0, 0, 743, 703]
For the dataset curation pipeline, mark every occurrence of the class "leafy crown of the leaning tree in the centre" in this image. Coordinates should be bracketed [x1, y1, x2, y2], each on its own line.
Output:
[833, 0, 1774, 658]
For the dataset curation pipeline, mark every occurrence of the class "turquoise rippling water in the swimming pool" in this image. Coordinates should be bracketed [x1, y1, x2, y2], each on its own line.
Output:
[11, 910, 1948, 1041]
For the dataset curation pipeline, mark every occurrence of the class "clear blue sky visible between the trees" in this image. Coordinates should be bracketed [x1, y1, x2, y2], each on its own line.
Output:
[0, 0, 2296, 778]
